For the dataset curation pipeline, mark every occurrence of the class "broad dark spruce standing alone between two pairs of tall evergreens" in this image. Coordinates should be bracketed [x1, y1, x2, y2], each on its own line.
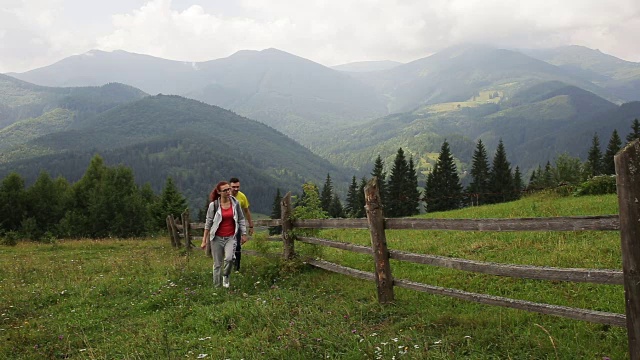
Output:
[425, 140, 462, 212]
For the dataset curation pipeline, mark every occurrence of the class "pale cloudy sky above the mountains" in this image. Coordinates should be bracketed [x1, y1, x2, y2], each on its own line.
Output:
[0, 0, 640, 73]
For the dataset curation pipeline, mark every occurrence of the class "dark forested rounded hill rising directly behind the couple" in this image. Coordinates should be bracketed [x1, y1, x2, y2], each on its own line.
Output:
[0, 95, 347, 213]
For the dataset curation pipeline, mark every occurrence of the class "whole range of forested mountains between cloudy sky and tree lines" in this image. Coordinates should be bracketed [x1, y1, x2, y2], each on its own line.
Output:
[0, 45, 640, 211]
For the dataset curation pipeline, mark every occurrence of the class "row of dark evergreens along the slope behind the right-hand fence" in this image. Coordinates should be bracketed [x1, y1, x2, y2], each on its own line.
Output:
[271, 119, 640, 219]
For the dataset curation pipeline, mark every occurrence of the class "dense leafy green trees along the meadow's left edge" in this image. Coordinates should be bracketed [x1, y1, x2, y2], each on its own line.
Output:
[0, 155, 187, 241]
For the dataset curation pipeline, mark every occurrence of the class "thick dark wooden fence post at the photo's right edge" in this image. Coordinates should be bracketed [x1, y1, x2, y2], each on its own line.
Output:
[614, 140, 640, 360]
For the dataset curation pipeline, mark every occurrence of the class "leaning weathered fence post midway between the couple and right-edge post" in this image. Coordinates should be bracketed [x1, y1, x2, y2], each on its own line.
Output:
[364, 177, 393, 304]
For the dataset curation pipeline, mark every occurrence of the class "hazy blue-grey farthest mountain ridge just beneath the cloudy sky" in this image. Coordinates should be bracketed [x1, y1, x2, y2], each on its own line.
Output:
[13, 45, 640, 146]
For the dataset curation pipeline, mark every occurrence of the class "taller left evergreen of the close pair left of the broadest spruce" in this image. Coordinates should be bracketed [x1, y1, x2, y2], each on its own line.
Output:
[385, 148, 411, 217]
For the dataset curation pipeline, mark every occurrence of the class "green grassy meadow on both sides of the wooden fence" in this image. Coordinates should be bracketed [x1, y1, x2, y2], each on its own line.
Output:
[0, 194, 628, 360]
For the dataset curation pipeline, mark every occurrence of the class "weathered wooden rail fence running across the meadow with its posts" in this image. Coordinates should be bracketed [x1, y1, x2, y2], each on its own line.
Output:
[167, 141, 640, 360]
